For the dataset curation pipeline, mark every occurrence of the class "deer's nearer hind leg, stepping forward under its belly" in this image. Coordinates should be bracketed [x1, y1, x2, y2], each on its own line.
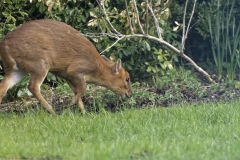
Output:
[28, 70, 55, 114]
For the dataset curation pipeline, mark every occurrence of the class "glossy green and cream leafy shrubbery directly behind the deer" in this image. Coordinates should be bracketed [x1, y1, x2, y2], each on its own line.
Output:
[0, 0, 178, 80]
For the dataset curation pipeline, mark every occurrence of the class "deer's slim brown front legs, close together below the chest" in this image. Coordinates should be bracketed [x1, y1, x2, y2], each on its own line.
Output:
[67, 74, 86, 114]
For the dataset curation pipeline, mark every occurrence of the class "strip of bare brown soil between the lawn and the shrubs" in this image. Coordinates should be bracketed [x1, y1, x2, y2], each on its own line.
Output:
[0, 84, 240, 114]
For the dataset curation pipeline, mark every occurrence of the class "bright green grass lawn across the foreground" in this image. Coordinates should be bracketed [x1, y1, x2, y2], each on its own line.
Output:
[0, 102, 240, 160]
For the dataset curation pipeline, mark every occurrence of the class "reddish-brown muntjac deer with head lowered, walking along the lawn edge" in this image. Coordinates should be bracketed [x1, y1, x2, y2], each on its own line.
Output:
[0, 20, 132, 114]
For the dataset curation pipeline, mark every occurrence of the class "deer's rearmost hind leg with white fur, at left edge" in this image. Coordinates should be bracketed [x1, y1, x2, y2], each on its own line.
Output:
[0, 69, 26, 103]
